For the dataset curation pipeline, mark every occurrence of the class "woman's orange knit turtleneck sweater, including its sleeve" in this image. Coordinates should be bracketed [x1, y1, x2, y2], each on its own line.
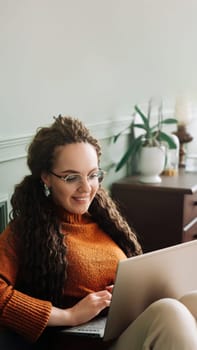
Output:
[0, 212, 126, 342]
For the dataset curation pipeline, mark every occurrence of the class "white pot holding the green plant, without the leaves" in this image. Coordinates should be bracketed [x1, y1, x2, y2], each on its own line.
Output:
[138, 146, 166, 183]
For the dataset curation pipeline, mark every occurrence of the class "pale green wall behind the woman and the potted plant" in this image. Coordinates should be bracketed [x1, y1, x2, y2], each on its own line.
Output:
[0, 0, 197, 219]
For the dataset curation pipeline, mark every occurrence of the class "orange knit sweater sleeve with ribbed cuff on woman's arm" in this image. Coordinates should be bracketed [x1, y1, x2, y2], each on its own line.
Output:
[0, 227, 52, 342]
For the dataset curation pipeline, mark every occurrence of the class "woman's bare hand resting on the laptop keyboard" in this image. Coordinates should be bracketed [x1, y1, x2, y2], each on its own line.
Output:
[67, 286, 112, 326]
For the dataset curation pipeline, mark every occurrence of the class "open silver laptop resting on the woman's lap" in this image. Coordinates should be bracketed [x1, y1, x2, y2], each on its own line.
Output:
[61, 240, 197, 341]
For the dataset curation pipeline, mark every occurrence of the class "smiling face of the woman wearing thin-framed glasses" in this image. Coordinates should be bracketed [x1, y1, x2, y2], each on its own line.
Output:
[42, 142, 99, 214]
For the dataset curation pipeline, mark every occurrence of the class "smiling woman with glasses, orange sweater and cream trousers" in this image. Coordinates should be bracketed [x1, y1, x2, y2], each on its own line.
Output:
[0, 116, 197, 350]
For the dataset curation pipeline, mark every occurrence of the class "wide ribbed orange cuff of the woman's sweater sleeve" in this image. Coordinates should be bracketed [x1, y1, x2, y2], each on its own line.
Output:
[3, 290, 52, 342]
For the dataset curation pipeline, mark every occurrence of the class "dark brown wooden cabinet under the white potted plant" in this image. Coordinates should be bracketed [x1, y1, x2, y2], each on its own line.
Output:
[112, 171, 197, 252]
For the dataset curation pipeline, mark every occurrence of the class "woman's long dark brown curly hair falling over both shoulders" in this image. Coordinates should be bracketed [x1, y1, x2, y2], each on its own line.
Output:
[10, 115, 141, 306]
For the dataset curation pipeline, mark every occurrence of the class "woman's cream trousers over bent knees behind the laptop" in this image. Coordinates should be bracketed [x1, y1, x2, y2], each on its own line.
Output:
[110, 291, 197, 350]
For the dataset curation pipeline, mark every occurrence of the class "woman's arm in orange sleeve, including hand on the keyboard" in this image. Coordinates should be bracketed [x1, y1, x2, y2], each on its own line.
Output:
[0, 229, 111, 342]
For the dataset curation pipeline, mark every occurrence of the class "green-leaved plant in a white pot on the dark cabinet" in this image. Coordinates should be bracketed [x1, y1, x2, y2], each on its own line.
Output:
[113, 100, 177, 182]
